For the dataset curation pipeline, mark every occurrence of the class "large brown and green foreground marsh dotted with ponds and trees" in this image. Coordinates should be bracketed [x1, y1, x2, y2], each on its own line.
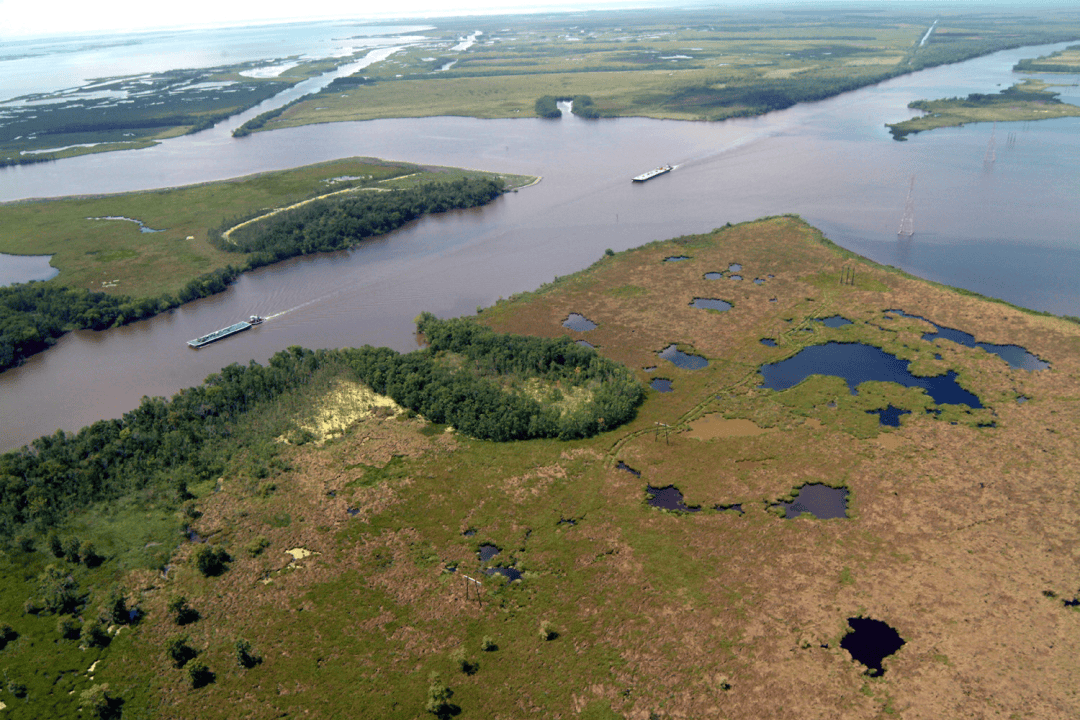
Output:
[0, 216, 1080, 720]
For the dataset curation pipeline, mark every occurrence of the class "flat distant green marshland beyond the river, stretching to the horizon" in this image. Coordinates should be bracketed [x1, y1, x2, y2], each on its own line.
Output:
[261, 10, 1080, 130]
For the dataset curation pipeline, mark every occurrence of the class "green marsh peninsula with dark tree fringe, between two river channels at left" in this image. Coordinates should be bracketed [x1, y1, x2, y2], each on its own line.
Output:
[0, 159, 532, 369]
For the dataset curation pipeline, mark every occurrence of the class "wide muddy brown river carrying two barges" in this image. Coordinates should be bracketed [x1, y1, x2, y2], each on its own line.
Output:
[0, 44, 1080, 449]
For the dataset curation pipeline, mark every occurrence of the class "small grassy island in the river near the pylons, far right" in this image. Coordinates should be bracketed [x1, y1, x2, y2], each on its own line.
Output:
[887, 80, 1080, 140]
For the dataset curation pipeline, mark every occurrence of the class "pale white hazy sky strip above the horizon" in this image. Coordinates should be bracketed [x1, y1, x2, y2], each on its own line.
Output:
[0, 0, 673, 38]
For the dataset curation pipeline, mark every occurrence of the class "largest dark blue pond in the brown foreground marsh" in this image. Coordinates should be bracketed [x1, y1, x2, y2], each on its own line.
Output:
[761, 342, 983, 408]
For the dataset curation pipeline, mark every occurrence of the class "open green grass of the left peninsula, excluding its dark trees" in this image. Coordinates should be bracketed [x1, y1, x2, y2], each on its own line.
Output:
[0, 158, 532, 298]
